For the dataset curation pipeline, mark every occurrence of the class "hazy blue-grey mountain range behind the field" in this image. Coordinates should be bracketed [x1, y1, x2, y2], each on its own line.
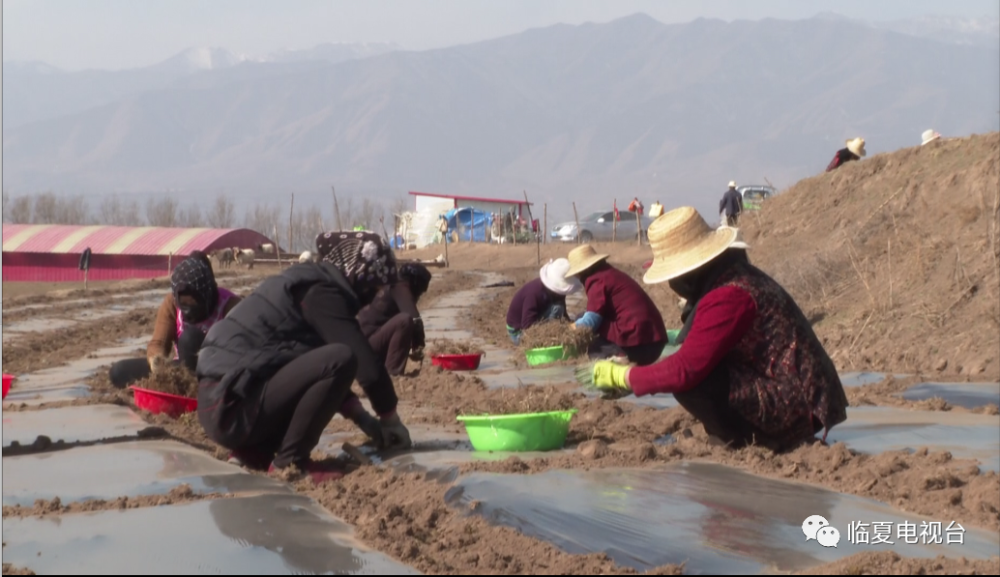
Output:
[3, 15, 1000, 216]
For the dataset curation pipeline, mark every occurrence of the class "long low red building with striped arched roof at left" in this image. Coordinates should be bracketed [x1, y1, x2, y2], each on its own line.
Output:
[3, 224, 271, 282]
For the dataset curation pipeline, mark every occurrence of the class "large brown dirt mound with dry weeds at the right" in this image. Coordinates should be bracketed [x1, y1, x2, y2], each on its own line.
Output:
[741, 133, 1000, 379]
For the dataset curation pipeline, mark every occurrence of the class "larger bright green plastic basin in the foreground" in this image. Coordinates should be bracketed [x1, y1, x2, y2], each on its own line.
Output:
[458, 409, 576, 451]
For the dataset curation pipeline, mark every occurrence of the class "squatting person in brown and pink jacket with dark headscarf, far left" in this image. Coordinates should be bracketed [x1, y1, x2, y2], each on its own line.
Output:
[109, 251, 241, 388]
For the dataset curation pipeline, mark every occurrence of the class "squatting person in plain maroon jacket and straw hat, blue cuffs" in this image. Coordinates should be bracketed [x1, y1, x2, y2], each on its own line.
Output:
[566, 244, 667, 365]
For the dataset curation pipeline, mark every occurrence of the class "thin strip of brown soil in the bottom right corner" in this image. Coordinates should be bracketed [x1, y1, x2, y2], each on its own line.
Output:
[796, 551, 1000, 575]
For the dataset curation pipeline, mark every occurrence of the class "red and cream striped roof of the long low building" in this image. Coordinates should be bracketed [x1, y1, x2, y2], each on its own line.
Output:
[3, 224, 271, 256]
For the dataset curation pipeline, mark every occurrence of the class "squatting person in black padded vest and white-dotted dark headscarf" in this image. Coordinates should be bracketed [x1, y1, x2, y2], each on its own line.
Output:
[197, 232, 410, 483]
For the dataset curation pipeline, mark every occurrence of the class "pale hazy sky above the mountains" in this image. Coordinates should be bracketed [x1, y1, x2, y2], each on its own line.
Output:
[3, 0, 1000, 70]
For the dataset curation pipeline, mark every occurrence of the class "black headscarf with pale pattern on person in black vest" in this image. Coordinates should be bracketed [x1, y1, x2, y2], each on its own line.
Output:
[316, 232, 398, 292]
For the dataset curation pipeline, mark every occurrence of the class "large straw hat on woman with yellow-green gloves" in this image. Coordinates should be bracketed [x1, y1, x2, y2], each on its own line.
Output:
[642, 206, 747, 284]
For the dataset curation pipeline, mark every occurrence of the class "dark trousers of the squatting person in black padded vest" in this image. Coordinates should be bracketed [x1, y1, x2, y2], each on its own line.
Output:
[238, 344, 358, 468]
